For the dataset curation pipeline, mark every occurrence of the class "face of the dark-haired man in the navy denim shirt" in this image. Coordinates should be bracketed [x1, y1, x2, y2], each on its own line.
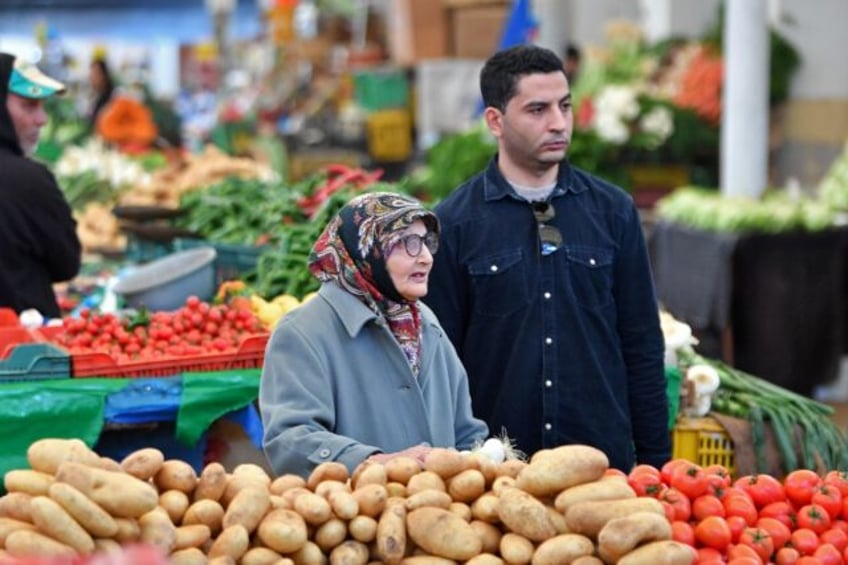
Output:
[487, 72, 574, 169]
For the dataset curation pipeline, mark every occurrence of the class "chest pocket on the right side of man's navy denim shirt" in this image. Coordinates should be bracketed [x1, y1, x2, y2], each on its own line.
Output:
[567, 245, 615, 308]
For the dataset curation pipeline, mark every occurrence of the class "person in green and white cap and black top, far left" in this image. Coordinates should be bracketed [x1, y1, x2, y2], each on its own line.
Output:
[0, 53, 81, 318]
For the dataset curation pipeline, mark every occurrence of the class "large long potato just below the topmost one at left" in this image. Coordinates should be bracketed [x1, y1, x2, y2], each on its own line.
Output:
[56, 461, 159, 518]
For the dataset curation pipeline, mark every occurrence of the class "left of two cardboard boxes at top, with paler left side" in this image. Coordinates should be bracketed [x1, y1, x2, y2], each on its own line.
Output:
[386, 0, 450, 66]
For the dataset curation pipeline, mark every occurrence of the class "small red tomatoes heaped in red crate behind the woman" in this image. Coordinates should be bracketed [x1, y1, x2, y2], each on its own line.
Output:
[52, 296, 265, 362]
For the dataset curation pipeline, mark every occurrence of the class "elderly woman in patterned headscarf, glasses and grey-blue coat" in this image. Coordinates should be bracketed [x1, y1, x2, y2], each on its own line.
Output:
[259, 192, 488, 476]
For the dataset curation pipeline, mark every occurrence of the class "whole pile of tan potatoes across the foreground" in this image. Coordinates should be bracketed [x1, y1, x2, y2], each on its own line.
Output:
[0, 439, 695, 565]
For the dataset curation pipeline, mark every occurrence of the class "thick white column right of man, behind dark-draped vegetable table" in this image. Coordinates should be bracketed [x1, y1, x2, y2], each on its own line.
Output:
[721, 0, 769, 197]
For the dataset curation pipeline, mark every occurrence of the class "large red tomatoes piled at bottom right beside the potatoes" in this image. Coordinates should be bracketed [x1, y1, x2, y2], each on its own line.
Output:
[627, 459, 848, 565]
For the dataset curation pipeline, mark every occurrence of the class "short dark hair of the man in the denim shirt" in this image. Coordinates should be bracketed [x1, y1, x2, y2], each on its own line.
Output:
[480, 45, 565, 112]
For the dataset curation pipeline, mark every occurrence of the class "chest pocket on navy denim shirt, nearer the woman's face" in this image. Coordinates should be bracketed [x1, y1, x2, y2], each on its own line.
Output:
[468, 249, 530, 317]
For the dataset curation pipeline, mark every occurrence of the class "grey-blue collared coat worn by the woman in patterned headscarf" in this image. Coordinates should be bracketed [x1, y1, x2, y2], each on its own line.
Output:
[259, 283, 488, 476]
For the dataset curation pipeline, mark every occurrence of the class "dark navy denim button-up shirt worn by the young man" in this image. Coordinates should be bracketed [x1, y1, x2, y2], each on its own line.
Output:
[424, 157, 671, 471]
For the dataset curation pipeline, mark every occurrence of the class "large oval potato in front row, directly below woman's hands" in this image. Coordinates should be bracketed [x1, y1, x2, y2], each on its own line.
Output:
[406, 507, 483, 561]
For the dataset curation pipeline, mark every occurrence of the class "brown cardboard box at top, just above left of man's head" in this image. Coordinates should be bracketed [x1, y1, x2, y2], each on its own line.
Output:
[448, 0, 509, 59]
